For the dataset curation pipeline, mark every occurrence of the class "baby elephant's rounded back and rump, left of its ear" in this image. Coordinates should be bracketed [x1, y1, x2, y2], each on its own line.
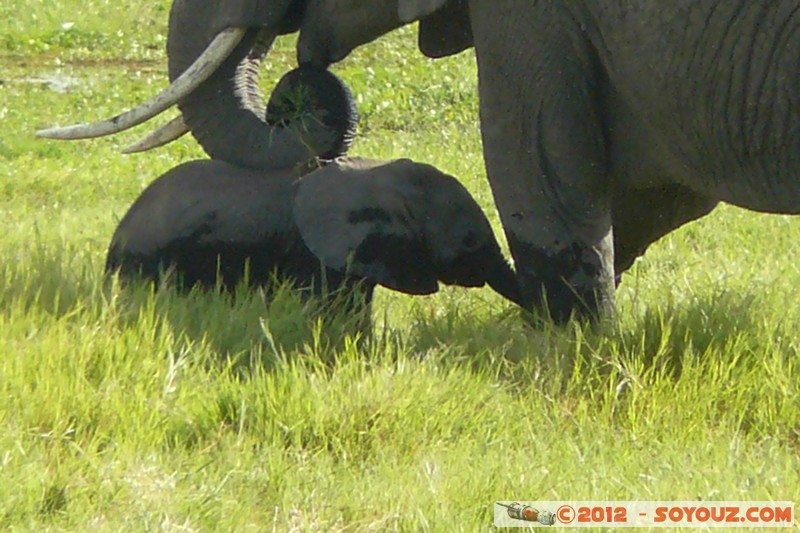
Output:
[106, 160, 297, 285]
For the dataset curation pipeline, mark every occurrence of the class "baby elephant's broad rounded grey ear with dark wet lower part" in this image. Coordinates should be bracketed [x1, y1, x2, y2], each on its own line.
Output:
[293, 159, 439, 294]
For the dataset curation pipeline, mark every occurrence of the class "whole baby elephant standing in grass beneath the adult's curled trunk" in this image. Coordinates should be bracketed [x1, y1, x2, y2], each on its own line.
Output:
[106, 158, 519, 302]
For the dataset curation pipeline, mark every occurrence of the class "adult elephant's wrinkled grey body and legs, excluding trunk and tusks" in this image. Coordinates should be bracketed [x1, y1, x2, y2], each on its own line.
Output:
[171, 0, 800, 320]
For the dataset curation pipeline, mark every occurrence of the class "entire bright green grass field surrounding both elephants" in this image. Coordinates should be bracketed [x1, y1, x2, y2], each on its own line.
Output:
[0, 0, 800, 531]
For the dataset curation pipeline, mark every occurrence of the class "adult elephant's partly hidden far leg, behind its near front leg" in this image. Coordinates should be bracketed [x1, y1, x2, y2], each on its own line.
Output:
[611, 184, 718, 286]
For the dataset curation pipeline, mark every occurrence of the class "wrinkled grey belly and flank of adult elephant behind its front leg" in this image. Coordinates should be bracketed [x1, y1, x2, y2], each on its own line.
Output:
[590, 0, 800, 213]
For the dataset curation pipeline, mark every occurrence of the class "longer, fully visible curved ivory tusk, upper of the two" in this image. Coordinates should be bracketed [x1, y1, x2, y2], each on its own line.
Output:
[36, 28, 247, 140]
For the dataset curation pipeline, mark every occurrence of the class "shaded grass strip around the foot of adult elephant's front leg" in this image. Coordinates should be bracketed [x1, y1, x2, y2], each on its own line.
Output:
[409, 284, 798, 391]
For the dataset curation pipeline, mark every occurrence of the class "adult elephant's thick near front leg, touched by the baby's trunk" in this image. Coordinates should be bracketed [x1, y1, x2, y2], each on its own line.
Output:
[470, 1, 614, 321]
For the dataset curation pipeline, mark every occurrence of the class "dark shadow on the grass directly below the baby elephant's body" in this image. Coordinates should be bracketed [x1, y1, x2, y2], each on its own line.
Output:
[107, 277, 370, 377]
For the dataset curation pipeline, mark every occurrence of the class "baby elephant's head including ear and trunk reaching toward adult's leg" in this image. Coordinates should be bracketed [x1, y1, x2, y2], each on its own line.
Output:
[293, 158, 519, 303]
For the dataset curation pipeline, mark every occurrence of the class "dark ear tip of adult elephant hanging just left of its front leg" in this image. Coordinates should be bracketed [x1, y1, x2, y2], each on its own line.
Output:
[397, 0, 473, 58]
